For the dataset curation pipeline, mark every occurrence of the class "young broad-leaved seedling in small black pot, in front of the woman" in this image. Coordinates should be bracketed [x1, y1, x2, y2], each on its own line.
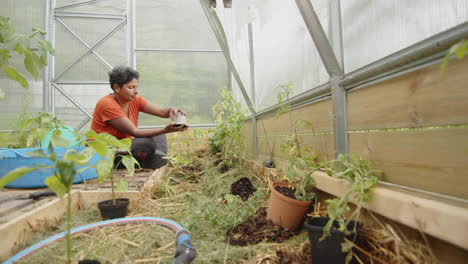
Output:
[87, 130, 138, 219]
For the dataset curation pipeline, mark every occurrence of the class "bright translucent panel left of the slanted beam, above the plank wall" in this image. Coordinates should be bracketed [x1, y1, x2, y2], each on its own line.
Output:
[219, 0, 330, 110]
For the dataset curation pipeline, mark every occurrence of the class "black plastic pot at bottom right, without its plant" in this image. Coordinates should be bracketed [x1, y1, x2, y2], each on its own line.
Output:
[304, 217, 361, 264]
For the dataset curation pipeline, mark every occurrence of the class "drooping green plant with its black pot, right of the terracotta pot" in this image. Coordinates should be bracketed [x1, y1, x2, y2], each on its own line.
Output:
[305, 153, 382, 263]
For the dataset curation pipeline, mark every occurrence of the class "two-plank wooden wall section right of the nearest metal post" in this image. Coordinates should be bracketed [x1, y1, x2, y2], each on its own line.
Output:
[347, 59, 468, 199]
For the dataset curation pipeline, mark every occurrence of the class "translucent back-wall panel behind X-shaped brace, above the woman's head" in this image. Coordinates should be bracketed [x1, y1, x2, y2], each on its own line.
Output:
[54, 0, 127, 83]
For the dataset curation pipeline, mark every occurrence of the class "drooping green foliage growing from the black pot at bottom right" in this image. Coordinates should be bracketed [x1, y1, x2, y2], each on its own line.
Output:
[322, 153, 382, 263]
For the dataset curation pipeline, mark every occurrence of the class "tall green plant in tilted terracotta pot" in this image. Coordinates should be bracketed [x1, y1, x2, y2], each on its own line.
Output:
[267, 85, 317, 230]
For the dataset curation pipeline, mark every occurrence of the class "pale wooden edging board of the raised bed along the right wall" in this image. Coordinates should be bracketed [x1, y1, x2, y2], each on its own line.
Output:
[312, 171, 468, 250]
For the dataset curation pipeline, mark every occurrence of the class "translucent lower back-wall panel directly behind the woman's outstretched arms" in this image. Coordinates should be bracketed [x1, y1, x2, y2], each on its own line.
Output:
[137, 52, 228, 126]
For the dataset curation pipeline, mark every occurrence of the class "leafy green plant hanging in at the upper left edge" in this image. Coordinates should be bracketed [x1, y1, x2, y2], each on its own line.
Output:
[0, 16, 55, 99]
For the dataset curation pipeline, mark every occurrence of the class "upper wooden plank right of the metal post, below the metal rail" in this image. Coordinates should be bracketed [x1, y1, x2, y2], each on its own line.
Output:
[347, 59, 468, 130]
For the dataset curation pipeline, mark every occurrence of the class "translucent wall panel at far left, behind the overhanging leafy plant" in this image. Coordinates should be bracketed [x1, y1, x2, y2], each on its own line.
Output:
[0, 0, 45, 129]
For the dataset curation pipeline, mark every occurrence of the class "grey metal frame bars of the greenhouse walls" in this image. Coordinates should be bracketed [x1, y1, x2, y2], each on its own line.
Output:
[0, 0, 468, 260]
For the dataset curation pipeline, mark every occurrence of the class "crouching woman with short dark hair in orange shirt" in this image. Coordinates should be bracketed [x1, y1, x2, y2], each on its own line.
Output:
[91, 66, 188, 169]
